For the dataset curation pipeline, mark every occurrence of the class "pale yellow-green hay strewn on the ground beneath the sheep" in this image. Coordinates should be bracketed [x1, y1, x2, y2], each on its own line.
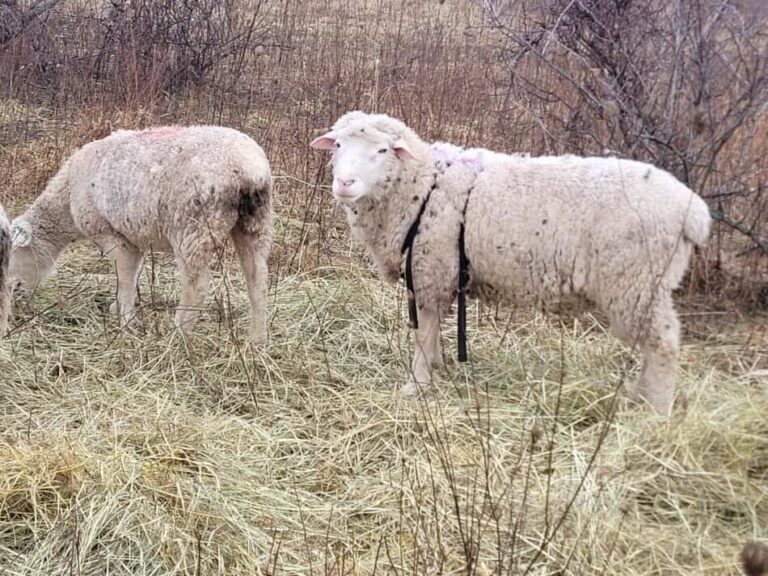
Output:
[0, 242, 768, 576]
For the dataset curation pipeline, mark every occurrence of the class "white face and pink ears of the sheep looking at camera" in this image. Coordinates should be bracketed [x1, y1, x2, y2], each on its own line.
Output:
[311, 127, 413, 203]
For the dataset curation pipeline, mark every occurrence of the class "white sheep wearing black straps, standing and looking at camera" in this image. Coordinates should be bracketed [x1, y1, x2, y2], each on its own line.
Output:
[311, 112, 710, 413]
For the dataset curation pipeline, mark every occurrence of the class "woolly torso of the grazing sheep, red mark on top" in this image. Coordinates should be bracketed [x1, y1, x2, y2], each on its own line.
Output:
[69, 127, 270, 248]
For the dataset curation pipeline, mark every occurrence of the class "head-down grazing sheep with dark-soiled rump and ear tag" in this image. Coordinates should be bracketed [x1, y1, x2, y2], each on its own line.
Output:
[10, 126, 272, 343]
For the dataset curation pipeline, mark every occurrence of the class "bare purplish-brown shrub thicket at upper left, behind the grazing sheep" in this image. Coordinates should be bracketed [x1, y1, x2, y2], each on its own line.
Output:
[0, 0, 267, 101]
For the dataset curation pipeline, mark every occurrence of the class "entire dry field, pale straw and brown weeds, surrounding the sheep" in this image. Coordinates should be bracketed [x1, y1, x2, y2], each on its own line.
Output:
[0, 0, 768, 576]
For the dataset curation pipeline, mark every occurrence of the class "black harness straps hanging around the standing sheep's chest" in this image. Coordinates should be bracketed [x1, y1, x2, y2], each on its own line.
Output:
[400, 174, 472, 362]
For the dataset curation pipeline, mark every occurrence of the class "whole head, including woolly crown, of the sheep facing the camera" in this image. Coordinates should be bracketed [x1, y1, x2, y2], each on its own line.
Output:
[310, 112, 414, 203]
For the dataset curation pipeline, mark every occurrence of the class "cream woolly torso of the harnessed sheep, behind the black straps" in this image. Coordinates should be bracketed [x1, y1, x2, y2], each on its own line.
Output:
[466, 157, 698, 300]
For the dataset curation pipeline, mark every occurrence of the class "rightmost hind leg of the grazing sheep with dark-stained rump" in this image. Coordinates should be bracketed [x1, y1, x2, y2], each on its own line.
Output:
[232, 228, 269, 346]
